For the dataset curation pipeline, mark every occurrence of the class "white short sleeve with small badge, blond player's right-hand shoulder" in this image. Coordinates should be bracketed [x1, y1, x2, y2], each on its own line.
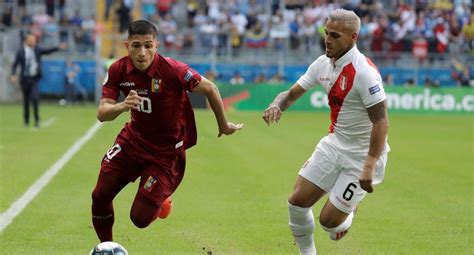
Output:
[355, 67, 387, 108]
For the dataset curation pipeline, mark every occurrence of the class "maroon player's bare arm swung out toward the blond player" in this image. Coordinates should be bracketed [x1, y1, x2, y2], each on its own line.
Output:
[193, 77, 243, 137]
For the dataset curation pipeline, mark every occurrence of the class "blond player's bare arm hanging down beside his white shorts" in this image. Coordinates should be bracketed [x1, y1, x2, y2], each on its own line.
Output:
[359, 100, 388, 193]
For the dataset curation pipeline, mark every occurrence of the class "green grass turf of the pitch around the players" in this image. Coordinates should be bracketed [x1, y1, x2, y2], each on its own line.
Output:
[0, 105, 474, 255]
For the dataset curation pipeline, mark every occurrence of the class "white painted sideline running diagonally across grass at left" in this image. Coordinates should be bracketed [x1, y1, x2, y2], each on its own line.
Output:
[0, 122, 102, 233]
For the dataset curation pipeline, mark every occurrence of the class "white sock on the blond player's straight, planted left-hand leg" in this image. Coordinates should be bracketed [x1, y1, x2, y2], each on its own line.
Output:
[288, 202, 316, 255]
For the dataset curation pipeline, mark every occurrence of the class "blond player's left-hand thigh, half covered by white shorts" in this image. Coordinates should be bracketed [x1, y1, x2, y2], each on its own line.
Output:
[289, 138, 339, 207]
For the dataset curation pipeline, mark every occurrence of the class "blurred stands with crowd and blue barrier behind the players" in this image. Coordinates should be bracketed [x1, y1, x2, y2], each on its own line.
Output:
[0, 0, 474, 105]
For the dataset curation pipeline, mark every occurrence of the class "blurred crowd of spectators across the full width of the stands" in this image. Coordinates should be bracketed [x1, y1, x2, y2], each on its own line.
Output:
[0, 0, 474, 86]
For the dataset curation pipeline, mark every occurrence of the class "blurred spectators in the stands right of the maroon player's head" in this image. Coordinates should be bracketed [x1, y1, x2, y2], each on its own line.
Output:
[142, 0, 474, 60]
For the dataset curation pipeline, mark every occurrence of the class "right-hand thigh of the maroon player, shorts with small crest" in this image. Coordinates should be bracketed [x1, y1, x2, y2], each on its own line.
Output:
[137, 151, 186, 206]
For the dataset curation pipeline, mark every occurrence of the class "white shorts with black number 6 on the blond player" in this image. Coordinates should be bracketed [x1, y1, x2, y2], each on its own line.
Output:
[299, 136, 387, 214]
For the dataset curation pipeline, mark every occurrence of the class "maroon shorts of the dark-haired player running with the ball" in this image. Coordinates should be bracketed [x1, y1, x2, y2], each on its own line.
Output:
[100, 140, 186, 206]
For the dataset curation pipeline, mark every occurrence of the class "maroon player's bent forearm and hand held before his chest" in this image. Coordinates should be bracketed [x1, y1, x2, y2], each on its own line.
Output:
[97, 90, 141, 122]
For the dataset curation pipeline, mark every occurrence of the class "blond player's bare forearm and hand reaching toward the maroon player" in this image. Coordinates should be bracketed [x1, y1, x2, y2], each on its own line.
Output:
[262, 83, 306, 125]
